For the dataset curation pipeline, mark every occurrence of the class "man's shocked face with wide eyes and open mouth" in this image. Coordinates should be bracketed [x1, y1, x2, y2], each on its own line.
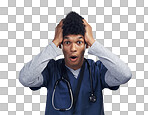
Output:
[63, 35, 85, 70]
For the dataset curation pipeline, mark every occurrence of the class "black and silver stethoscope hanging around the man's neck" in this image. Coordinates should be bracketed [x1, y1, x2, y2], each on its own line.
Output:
[52, 58, 97, 111]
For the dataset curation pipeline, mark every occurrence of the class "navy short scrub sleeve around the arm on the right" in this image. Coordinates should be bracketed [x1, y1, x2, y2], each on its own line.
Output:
[96, 61, 120, 90]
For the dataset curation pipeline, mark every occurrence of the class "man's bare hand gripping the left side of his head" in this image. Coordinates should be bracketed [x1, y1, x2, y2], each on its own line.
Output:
[52, 20, 63, 48]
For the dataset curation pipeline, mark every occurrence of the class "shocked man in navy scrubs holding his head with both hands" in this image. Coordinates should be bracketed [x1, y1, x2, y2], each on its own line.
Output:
[19, 12, 132, 115]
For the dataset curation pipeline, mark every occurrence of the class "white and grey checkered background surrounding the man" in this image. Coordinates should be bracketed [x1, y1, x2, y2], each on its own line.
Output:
[0, 0, 148, 115]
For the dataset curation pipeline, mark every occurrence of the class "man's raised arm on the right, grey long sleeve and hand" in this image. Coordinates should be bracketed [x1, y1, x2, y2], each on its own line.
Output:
[83, 20, 132, 86]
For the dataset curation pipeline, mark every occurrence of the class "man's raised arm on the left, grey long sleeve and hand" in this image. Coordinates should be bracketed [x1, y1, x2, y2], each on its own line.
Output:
[19, 21, 63, 87]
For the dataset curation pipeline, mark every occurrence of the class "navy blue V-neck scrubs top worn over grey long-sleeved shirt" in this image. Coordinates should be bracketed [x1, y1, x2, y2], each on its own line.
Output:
[30, 59, 119, 115]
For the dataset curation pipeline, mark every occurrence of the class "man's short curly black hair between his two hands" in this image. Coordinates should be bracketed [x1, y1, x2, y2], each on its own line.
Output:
[62, 11, 85, 38]
